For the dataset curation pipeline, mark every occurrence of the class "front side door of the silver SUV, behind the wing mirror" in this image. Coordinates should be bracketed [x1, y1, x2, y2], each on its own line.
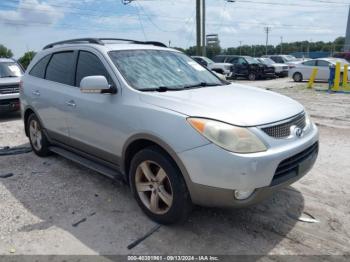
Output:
[68, 50, 123, 164]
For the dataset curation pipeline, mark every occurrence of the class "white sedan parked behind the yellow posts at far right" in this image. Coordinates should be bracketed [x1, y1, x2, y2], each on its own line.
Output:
[289, 58, 347, 82]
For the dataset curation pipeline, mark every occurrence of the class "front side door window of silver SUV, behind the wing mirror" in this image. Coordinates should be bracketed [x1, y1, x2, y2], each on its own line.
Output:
[75, 51, 111, 86]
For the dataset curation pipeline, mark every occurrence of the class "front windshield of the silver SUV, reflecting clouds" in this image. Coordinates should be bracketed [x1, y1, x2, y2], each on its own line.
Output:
[109, 50, 222, 91]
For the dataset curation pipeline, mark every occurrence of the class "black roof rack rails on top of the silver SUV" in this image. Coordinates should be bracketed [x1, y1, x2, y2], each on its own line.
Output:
[43, 38, 167, 49]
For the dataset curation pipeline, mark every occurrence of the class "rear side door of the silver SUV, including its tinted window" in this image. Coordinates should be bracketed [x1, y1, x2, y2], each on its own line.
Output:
[30, 51, 76, 141]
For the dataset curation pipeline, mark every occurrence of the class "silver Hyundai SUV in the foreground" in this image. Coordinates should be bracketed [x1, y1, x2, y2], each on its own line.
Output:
[21, 38, 318, 224]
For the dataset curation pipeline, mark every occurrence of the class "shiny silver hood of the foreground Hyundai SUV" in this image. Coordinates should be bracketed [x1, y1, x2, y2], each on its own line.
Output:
[140, 84, 304, 126]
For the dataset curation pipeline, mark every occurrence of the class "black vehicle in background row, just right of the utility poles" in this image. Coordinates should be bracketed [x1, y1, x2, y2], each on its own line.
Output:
[213, 55, 275, 81]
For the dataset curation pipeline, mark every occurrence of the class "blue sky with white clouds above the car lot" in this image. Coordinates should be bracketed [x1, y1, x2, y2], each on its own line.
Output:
[0, 0, 350, 58]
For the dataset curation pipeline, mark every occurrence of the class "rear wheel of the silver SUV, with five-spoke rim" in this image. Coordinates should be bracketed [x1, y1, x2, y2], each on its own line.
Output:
[27, 114, 51, 157]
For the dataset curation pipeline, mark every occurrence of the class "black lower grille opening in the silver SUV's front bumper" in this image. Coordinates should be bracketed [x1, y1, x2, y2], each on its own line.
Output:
[271, 142, 318, 186]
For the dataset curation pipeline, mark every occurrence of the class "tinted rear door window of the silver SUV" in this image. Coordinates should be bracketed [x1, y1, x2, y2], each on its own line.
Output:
[45, 52, 74, 85]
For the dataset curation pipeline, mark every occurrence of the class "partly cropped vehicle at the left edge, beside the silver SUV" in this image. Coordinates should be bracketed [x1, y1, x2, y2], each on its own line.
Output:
[0, 58, 23, 112]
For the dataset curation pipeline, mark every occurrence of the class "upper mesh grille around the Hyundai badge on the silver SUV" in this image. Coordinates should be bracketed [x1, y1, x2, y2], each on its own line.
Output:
[261, 114, 306, 138]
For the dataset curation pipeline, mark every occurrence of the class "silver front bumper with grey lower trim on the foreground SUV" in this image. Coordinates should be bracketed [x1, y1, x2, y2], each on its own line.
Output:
[179, 125, 318, 207]
